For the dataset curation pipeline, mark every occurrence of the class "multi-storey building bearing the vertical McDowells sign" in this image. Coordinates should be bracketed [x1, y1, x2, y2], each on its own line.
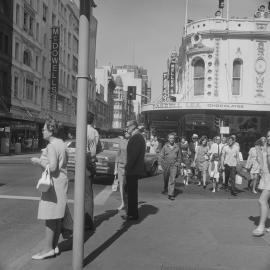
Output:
[0, 0, 97, 153]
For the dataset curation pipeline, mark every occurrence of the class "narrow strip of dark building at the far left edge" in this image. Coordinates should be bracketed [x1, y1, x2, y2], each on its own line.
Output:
[0, 0, 13, 152]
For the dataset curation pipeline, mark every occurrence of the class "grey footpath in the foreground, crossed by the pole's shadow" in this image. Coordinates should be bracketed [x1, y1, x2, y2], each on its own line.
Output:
[8, 182, 270, 270]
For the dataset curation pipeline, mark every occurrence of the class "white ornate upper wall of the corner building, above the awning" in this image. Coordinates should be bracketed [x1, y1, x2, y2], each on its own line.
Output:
[176, 16, 270, 107]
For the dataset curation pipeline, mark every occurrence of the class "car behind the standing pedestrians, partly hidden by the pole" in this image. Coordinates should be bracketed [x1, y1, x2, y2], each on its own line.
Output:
[67, 138, 158, 176]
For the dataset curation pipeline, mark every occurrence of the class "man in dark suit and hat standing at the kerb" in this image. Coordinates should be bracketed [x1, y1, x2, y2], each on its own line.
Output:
[124, 120, 146, 220]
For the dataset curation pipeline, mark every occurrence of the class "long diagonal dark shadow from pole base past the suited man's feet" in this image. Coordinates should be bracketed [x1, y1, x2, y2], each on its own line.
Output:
[83, 204, 158, 266]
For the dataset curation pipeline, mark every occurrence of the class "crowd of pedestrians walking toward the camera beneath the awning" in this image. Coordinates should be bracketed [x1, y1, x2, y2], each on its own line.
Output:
[156, 133, 266, 200]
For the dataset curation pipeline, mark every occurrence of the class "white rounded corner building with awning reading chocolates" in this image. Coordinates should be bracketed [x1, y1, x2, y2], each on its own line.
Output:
[143, 6, 270, 158]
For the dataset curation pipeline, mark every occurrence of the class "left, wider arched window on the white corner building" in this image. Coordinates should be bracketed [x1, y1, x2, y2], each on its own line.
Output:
[193, 58, 205, 96]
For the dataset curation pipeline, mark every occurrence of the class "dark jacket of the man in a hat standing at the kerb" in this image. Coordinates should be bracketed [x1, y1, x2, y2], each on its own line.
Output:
[126, 132, 146, 176]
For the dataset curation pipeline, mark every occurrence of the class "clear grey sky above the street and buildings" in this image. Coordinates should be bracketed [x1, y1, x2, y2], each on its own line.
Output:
[93, 0, 268, 101]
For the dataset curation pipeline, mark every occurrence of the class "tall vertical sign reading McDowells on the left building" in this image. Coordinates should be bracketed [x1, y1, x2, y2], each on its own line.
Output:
[50, 26, 60, 96]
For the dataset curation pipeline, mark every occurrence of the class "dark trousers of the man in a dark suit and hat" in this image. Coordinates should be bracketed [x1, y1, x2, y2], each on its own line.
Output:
[126, 175, 140, 219]
